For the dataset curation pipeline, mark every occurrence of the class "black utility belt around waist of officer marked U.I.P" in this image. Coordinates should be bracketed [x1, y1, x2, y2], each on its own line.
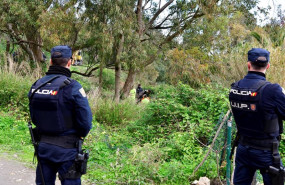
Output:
[239, 136, 279, 151]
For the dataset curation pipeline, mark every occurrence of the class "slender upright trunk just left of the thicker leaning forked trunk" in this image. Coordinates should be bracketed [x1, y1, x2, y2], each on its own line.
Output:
[114, 34, 124, 103]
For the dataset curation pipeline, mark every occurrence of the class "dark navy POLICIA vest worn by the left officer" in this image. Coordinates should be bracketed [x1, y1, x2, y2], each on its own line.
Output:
[29, 76, 75, 135]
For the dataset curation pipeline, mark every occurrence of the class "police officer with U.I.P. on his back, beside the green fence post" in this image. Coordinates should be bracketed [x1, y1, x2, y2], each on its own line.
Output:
[229, 48, 285, 185]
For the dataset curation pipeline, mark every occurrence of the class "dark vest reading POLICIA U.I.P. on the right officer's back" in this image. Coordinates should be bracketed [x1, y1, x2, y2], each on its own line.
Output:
[229, 80, 280, 139]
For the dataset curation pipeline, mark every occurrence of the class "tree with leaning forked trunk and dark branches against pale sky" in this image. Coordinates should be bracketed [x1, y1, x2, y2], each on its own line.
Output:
[118, 0, 214, 97]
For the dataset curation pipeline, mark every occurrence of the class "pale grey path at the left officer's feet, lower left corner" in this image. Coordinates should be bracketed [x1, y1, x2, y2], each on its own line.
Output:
[0, 156, 60, 185]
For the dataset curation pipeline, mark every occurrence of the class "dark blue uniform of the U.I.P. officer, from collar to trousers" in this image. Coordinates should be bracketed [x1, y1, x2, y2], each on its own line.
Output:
[230, 71, 285, 185]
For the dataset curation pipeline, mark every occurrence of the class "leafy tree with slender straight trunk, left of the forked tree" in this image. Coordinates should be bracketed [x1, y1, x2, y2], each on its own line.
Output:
[75, 0, 135, 101]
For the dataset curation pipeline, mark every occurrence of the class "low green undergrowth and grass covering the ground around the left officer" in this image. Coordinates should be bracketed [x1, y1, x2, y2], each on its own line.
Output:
[0, 72, 227, 184]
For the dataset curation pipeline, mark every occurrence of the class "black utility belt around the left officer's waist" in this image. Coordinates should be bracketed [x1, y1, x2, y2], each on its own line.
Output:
[40, 135, 80, 148]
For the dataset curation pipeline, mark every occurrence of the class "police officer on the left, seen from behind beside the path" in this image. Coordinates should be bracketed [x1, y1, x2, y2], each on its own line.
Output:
[29, 46, 92, 185]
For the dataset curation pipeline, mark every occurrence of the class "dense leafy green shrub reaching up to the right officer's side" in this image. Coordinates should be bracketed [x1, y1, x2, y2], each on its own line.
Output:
[128, 84, 228, 144]
